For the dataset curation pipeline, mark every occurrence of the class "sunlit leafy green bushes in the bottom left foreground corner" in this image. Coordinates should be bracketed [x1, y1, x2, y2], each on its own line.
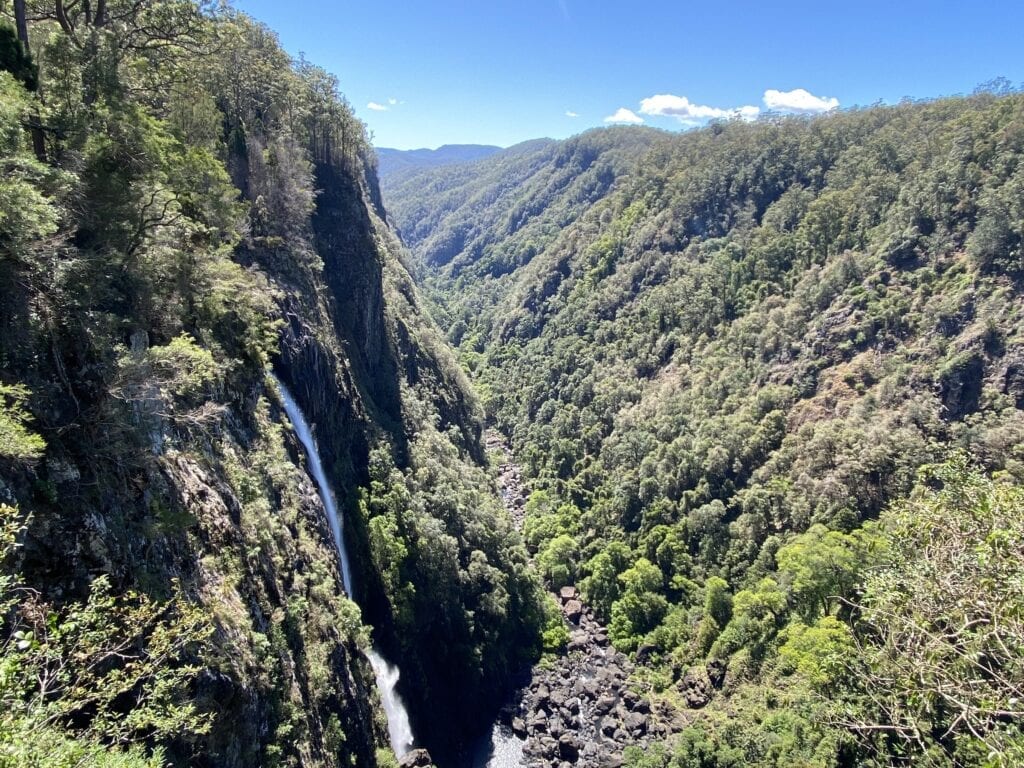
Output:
[0, 505, 212, 768]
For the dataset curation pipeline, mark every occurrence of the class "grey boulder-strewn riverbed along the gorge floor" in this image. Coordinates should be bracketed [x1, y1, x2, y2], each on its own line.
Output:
[481, 430, 672, 768]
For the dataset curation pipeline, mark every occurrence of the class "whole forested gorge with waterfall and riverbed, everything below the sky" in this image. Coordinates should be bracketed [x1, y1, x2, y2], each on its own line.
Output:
[0, 0, 1024, 768]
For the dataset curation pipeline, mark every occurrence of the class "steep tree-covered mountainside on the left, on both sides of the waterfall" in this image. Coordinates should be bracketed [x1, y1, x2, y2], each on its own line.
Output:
[0, 0, 544, 768]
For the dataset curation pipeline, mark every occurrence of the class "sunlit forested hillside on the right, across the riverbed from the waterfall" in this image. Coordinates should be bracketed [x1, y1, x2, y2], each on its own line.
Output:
[385, 93, 1024, 768]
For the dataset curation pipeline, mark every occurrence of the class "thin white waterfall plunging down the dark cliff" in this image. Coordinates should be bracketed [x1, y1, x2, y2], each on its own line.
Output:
[271, 374, 414, 758]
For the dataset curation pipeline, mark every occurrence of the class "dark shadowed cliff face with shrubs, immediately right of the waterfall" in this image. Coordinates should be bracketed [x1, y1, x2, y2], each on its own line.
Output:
[264, 159, 540, 762]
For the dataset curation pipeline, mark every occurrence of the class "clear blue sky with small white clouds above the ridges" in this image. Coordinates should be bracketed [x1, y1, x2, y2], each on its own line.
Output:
[233, 0, 1024, 148]
